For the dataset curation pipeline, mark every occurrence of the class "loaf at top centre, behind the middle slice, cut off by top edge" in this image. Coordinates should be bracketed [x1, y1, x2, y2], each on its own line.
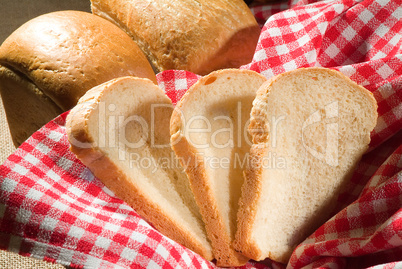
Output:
[91, 0, 260, 75]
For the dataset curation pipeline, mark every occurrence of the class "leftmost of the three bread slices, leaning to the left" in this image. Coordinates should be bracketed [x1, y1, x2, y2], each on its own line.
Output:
[66, 77, 213, 260]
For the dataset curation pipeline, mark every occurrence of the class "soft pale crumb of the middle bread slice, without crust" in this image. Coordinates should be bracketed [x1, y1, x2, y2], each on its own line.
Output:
[177, 75, 258, 236]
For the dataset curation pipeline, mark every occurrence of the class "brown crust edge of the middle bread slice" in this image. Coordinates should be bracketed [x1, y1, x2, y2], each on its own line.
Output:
[170, 69, 265, 266]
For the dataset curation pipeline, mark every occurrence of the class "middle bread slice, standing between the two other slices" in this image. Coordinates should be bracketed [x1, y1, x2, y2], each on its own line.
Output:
[170, 69, 266, 266]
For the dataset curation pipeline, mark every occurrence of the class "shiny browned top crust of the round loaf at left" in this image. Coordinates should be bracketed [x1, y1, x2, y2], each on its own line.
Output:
[0, 11, 156, 110]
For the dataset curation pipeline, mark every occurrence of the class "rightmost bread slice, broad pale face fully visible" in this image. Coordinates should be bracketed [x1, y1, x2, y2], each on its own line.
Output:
[234, 68, 377, 263]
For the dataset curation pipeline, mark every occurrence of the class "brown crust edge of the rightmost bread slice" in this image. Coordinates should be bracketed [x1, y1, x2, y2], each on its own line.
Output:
[234, 67, 377, 263]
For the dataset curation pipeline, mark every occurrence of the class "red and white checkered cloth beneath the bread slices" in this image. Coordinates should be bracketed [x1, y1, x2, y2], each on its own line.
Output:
[0, 0, 402, 268]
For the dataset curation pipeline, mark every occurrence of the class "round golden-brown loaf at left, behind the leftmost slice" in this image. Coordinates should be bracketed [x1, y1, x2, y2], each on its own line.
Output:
[0, 11, 156, 146]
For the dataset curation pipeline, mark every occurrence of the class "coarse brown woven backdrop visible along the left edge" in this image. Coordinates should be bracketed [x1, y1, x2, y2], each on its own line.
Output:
[0, 0, 90, 269]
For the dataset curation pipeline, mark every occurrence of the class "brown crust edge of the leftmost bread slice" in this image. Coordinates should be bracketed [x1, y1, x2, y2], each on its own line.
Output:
[66, 77, 213, 260]
